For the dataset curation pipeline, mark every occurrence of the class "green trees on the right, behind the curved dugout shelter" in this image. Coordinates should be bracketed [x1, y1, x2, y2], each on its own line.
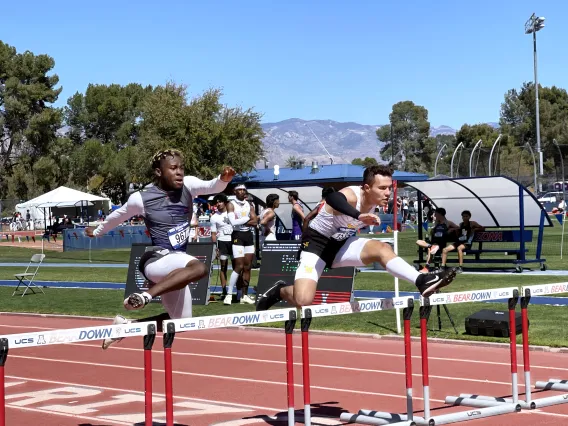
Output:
[352, 83, 568, 184]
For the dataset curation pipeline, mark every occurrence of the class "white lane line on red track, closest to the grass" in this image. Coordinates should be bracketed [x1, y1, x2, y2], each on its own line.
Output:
[0, 324, 568, 371]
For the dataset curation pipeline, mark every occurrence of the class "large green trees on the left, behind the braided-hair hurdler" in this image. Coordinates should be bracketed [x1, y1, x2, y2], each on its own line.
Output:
[0, 41, 264, 203]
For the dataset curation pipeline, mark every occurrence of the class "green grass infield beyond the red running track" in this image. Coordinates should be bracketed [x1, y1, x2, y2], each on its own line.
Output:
[0, 267, 568, 347]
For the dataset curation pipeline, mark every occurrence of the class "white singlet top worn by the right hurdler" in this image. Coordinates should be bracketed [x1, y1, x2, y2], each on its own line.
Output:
[309, 186, 376, 241]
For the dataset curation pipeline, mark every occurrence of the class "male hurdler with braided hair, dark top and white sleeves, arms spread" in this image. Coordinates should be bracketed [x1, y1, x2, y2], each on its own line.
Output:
[85, 149, 235, 349]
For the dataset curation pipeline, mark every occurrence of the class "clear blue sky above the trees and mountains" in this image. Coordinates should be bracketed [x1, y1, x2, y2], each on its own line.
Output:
[0, 0, 568, 128]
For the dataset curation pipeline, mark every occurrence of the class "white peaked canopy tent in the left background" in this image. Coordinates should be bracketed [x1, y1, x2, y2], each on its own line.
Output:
[16, 186, 111, 226]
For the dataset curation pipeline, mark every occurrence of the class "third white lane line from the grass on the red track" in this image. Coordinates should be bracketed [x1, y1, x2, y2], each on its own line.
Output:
[6, 355, 446, 402]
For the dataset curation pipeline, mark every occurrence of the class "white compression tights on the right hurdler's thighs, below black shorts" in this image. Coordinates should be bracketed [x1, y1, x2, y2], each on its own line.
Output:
[294, 237, 370, 282]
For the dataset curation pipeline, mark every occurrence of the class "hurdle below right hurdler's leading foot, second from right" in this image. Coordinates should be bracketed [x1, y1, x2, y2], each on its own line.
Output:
[416, 287, 521, 426]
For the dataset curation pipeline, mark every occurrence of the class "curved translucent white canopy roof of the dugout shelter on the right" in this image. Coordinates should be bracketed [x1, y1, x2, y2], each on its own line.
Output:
[405, 176, 553, 228]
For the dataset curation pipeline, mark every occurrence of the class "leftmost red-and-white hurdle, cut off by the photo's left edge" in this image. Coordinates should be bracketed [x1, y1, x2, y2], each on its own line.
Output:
[0, 321, 157, 426]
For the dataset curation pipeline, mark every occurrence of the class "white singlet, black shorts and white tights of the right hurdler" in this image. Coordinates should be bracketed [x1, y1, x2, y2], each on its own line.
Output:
[295, 186, 376, 281]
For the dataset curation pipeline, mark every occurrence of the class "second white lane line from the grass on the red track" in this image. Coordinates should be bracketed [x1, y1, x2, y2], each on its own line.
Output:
[62, 343, 511, 386]
